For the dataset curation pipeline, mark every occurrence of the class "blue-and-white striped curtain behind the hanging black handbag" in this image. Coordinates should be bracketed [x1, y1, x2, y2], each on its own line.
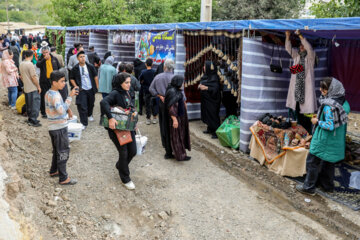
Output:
[240, 38, 328, 152]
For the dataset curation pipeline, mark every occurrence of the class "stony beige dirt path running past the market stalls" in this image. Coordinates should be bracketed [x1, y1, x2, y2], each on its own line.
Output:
[0, 92, 358, 240]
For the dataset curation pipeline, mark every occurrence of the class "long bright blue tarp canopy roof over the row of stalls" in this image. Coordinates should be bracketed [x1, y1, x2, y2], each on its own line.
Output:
[47, 17, 360, 39]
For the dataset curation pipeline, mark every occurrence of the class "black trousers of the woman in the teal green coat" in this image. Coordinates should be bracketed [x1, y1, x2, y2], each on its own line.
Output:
[304, 153, 335, 191]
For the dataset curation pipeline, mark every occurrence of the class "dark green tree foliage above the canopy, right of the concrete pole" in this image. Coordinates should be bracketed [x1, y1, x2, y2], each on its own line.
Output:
[213, 0, 305, 20]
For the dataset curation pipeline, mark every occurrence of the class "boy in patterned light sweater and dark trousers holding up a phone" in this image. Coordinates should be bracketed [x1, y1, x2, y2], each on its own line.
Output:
[45, 71, 78, 185]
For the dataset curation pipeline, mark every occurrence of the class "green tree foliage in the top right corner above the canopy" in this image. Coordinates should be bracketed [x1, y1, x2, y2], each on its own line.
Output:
[310, 0, 360, 18]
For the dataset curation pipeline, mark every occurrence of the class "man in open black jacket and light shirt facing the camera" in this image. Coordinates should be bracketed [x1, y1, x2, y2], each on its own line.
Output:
[70, 51, 99, 129]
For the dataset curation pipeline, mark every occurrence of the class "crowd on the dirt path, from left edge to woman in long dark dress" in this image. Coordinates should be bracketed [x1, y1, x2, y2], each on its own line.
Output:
[0, 34, 191, 189]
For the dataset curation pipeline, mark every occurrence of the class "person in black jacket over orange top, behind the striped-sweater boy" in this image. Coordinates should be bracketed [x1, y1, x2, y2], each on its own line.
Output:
[36, 47, 60, 118]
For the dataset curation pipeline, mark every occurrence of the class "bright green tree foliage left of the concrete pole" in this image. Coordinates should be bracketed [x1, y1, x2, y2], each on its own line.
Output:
[48, 0, 200, 26]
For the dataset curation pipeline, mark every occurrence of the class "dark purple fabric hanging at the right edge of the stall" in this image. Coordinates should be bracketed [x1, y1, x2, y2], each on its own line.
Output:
[330, 40, 360, 111]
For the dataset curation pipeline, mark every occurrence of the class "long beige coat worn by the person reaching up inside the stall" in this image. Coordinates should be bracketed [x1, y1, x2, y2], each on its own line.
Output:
[285, 38, 317, 113]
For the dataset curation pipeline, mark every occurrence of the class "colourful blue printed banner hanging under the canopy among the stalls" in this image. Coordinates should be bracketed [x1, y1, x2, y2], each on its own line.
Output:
[136, 30, 176, 64]
